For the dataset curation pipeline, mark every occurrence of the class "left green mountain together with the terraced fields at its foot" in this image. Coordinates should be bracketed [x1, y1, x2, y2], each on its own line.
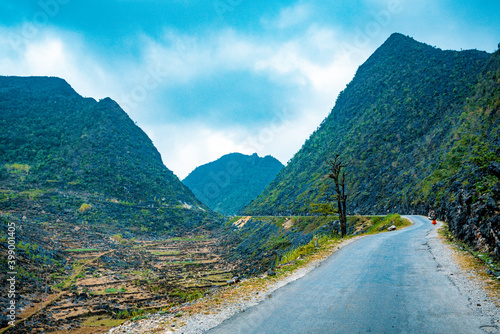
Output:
[0, 77, 226, 333]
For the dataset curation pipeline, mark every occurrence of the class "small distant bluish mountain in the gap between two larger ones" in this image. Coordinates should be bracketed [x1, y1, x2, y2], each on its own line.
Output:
[182, 153, 283, 215]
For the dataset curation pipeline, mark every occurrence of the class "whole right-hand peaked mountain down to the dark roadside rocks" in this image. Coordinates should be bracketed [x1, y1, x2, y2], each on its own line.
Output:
[242, 34, 500, 254]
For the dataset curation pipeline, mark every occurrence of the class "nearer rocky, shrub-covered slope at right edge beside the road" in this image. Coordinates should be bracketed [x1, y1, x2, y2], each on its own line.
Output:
[424, 50, 500, 258]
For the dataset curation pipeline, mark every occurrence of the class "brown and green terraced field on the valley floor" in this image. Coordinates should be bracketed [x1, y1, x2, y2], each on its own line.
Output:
[0, 218, 234, 333]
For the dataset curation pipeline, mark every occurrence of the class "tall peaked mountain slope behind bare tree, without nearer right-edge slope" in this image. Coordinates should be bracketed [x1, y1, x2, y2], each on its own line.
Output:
[244, 34, 489, 215]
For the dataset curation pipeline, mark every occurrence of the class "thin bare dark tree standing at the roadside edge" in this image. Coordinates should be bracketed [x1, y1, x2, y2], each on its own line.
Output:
[327, 154, 347, 237]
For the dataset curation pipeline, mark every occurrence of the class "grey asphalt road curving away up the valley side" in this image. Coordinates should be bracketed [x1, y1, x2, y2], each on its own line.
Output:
[208, 216, 496, 334]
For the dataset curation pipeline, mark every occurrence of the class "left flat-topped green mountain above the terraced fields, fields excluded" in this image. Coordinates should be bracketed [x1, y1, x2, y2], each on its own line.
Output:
[0, 77, 216, 230]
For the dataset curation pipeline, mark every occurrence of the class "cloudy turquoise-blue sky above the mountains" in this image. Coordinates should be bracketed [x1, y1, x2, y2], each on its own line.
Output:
[0, 0, 500, 179]
